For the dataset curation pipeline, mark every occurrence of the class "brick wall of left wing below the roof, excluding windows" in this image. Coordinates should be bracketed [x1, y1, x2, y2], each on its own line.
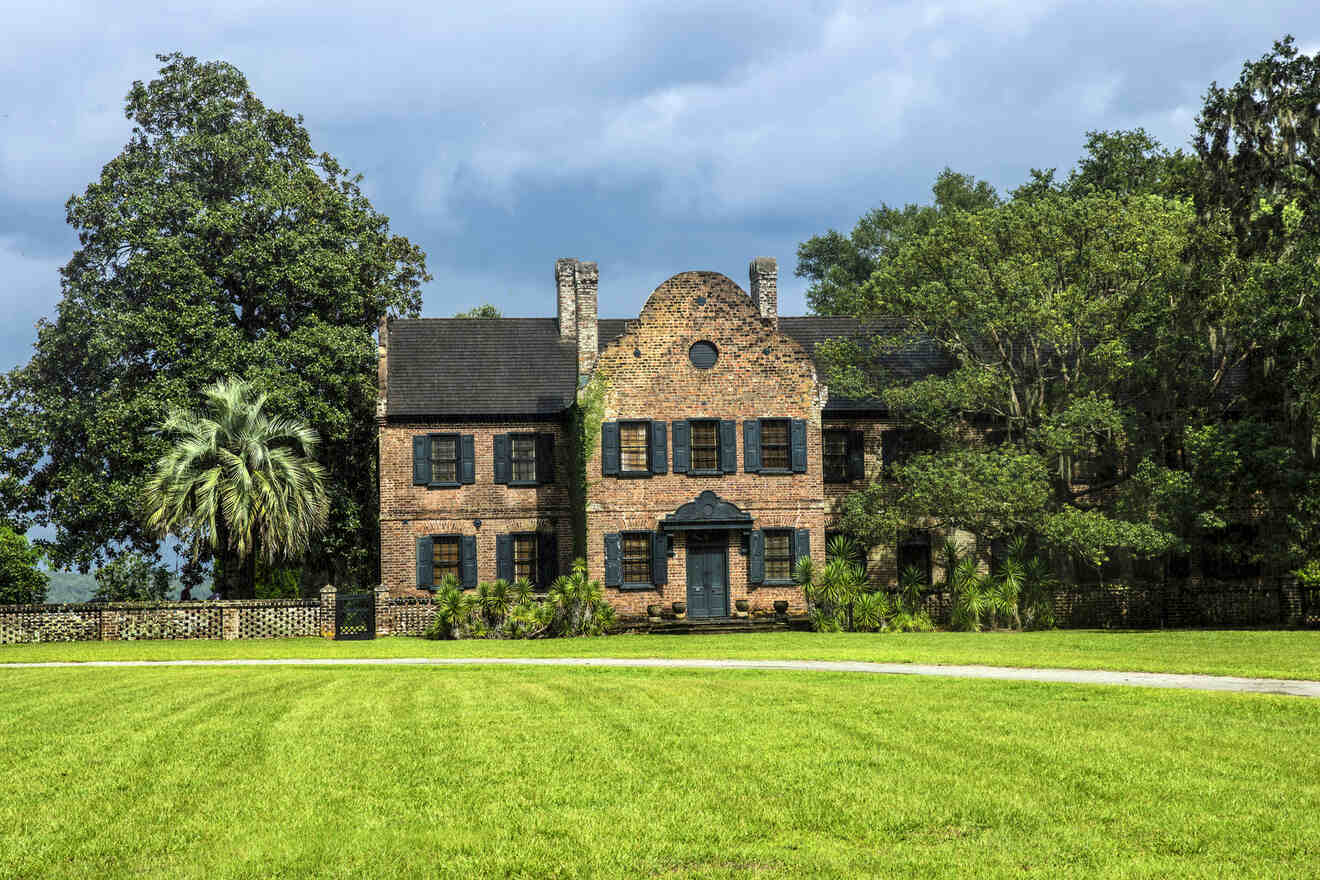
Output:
[380, 420, 573, 595]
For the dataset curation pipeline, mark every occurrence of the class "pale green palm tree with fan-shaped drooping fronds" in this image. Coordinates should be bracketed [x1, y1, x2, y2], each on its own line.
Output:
[144, 379, 329, 598]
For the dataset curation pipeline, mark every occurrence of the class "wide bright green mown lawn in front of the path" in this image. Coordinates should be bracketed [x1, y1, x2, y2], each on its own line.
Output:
[0, 668, 1320, 880]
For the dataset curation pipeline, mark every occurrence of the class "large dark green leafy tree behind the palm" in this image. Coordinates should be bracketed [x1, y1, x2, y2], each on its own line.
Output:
[0, 54, 429, 581]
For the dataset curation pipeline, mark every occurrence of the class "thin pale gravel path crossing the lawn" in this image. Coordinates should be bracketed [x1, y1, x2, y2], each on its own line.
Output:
[0, 657, 1320, 698]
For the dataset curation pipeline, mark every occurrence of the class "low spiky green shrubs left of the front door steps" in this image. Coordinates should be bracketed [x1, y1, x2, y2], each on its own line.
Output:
[425, 559, 616, 639]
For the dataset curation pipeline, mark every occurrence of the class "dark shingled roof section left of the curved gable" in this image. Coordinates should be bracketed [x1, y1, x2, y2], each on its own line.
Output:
[388, 318, 577, 417]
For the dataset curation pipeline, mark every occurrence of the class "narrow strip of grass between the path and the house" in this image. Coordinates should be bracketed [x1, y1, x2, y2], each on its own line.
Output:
[0, 629, 1320, 679]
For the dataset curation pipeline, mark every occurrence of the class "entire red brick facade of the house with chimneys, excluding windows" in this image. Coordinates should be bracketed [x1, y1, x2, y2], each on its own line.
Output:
[379, 259, 908, 619]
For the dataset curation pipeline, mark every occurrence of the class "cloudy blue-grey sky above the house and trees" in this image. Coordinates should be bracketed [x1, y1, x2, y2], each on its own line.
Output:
[0, 0, 1320, 369]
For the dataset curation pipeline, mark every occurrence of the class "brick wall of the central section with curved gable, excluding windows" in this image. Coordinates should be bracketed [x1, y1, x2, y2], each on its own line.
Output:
[586, 272, 825, 617]
